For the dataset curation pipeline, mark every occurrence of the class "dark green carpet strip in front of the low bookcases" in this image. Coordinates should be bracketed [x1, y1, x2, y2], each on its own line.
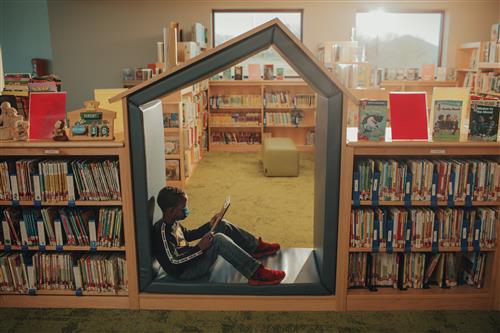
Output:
[0, 309, 500, 333]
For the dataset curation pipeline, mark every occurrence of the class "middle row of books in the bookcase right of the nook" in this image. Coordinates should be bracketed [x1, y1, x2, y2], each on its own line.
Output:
[349, 207, 499, 252]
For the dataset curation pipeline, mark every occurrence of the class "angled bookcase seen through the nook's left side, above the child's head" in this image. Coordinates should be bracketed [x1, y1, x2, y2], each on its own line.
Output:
[162, 81, 207, 188]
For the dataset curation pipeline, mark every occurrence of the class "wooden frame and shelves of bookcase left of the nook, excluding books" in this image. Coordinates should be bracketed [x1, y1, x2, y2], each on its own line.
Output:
[0, 141, 139, 308]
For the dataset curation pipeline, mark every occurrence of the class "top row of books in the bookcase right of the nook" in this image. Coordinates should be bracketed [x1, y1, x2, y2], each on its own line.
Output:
[353, 158, 500, 204]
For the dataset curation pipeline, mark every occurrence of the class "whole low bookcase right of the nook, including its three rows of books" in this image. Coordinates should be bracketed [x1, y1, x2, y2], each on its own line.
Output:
[338, 134, 500, 310]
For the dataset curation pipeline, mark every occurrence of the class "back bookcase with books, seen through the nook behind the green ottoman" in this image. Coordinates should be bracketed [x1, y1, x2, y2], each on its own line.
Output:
[209, 80, 316, 151]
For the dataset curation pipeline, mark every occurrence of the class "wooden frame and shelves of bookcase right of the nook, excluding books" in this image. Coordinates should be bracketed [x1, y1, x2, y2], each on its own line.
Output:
[337, 129, 500, 311]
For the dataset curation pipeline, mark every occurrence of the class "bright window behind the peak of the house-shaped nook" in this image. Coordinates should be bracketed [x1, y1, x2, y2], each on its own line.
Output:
[212, 10, 302, 76]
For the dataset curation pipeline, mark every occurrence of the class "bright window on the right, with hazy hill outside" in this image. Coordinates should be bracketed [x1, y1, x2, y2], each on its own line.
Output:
[355, 11, 443, 68]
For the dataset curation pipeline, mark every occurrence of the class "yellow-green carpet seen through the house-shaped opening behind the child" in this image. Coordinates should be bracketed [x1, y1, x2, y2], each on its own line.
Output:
[184, 152, 314, 248]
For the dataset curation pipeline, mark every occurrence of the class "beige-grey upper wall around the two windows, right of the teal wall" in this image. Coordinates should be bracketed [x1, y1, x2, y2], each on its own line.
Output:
[44, 0, 500, 109]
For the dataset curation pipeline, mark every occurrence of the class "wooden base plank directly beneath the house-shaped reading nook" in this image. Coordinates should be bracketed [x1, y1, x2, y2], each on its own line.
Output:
[139, 294, 337, 311]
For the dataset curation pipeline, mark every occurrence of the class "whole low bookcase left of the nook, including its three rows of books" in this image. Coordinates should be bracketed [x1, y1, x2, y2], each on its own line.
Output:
[0, 141, 137, 308]
